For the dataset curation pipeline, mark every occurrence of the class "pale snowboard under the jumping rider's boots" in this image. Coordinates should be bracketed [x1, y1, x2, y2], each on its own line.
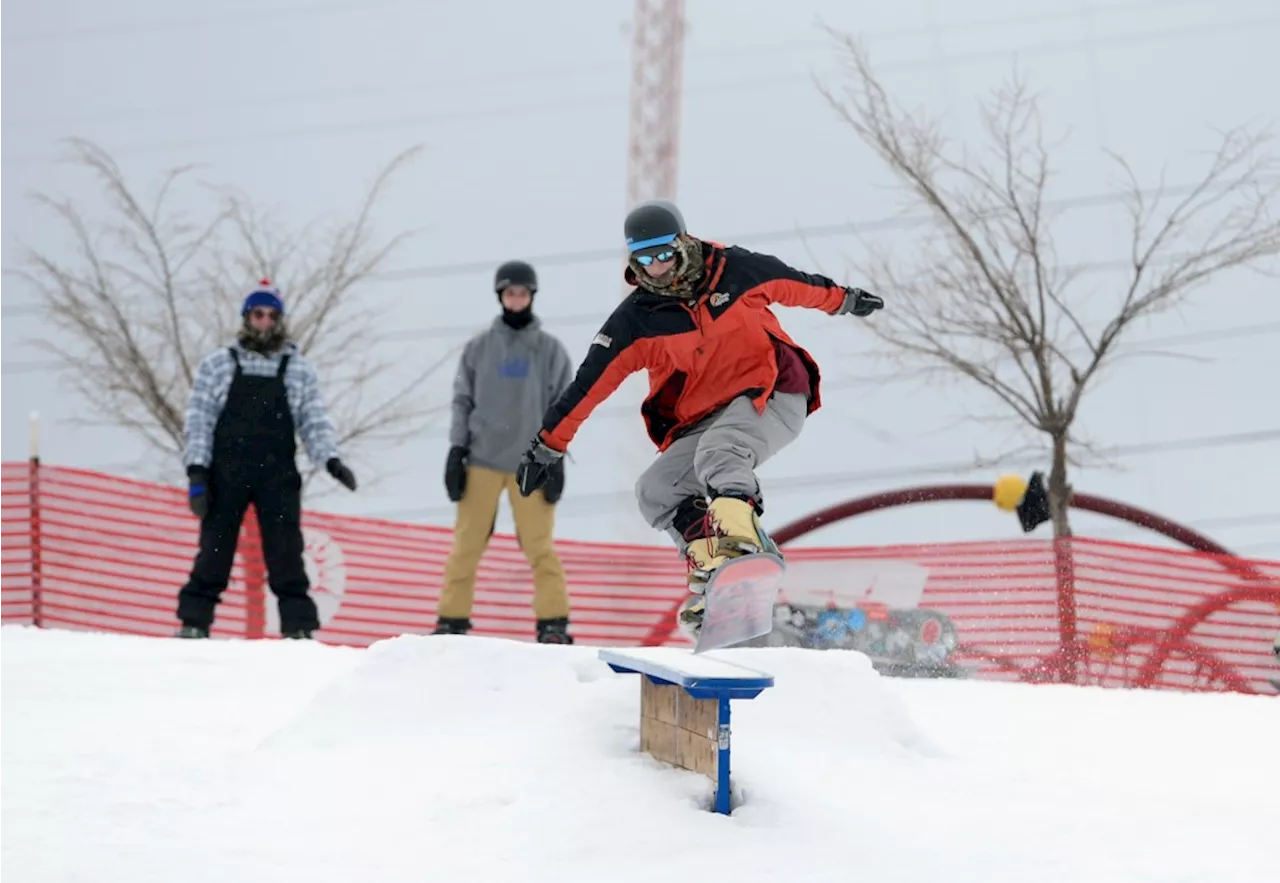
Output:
[694, 552, 786, 654]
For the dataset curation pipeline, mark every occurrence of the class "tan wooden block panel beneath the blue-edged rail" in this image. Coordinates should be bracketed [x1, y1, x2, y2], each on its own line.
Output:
[640, 678, 719, 782]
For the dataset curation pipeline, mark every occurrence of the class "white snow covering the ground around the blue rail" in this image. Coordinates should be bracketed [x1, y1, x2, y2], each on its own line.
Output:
[0, 627, 1280, 883]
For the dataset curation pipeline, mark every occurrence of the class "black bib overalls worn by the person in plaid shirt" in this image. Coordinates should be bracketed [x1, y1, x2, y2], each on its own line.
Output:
[178, 348, 320, 635]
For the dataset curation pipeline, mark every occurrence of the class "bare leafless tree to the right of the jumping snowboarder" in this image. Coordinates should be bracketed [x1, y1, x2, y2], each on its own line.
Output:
[819, 31, 1280, 536]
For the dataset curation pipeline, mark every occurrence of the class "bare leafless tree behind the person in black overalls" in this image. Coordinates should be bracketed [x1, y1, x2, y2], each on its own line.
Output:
[22, 139, 453, 491]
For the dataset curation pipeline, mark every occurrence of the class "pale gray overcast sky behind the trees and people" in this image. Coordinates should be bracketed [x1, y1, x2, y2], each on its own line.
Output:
[0, 0, 1280, 557]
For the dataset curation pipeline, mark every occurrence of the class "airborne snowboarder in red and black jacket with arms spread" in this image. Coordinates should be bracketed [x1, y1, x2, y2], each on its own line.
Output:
[517, 200, 884, 630]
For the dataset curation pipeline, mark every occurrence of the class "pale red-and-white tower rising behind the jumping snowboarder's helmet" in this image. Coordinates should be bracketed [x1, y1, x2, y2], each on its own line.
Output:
[627, 0, 685, 210]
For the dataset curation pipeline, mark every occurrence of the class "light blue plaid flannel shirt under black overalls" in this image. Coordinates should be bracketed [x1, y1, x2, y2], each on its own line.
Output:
[182, 343, 338, 467]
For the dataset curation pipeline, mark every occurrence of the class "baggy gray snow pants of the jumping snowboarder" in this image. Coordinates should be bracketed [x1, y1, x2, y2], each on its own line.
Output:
[636, 393, 809, 553]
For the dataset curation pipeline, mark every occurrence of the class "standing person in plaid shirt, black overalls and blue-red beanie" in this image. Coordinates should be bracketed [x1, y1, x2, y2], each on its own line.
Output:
[178, 279, 356, 639]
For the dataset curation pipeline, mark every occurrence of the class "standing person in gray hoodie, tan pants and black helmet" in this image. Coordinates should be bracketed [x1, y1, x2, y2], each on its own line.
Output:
[434, 261, 573, 644]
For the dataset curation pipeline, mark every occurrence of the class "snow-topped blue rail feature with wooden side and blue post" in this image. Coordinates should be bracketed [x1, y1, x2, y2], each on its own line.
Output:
[599, 648, 773, 815]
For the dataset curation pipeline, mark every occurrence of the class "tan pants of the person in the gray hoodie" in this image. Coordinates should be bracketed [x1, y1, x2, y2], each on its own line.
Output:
[438, 466, 568, 619]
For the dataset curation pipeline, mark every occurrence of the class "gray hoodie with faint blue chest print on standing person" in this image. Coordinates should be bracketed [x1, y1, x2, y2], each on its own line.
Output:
[449, 316, 573, 472]
